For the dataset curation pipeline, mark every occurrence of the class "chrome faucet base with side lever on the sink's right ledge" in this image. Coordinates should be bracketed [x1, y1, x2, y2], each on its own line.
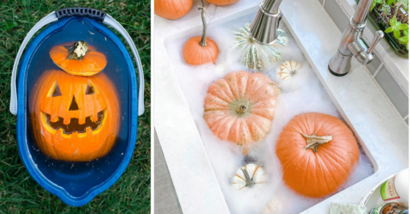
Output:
[329, 0, 384, 76]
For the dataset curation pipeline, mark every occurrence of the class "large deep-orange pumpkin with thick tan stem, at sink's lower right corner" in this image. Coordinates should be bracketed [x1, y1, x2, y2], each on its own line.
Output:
[276, 113, 359, 198]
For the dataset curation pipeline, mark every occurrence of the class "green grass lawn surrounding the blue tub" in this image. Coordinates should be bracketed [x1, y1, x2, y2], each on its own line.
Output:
[0, 0, 151, 213]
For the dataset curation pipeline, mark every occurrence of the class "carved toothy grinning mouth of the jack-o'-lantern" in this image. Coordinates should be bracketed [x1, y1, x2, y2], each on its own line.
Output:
[40, 110, 106, 137]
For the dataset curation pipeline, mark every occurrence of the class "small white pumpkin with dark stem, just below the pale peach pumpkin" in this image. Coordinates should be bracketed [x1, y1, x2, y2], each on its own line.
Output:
[231, 163, 267, 190]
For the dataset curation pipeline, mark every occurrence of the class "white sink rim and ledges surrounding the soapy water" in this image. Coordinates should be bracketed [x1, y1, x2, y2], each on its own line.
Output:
[154, 0, 408, 214]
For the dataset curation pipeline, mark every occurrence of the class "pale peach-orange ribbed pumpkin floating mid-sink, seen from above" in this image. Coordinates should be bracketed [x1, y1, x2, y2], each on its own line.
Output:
[204, 71, 280, 153]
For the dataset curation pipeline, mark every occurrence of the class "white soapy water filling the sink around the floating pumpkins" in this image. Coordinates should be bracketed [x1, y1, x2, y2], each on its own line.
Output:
[166, 14, 374, 214]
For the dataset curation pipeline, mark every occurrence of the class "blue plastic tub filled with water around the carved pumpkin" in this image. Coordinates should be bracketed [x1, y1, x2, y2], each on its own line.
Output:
[17, 16, 139, 206]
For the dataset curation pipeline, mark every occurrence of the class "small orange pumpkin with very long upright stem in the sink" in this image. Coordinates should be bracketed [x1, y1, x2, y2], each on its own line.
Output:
[182, 0, 219, 65]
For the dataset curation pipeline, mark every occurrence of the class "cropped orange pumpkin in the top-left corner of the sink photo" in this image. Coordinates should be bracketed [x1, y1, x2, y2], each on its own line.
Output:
[154, 0, 194, 19]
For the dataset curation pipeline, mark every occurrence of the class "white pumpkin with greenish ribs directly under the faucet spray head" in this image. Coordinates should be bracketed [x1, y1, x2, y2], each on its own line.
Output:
[235, 24, 289, 71]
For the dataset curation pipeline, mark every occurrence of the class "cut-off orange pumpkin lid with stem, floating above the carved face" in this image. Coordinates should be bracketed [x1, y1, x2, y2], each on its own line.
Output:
[50, 41, 107, 76]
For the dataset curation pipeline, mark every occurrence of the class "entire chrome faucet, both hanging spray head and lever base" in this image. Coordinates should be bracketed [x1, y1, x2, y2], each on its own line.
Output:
[250, 0, 384, 76]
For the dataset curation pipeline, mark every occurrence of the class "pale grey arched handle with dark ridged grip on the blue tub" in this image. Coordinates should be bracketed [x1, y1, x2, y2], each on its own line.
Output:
[10, 8, 145, 116]
